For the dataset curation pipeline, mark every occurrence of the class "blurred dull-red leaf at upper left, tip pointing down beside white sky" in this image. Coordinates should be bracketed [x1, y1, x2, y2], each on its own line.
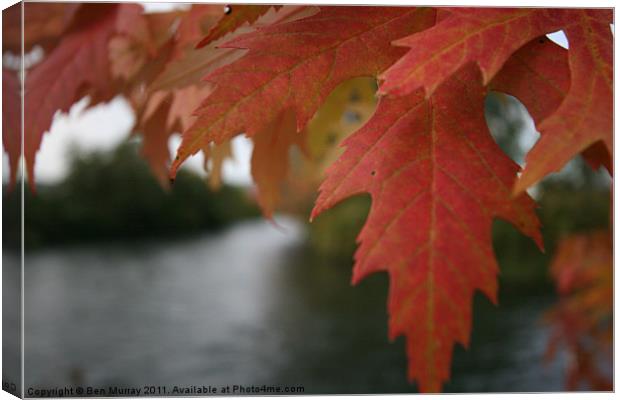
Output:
[24, 4, 149, 185]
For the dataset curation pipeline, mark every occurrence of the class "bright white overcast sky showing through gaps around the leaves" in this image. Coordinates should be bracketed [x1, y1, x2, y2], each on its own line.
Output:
[2, 3, 568, 185]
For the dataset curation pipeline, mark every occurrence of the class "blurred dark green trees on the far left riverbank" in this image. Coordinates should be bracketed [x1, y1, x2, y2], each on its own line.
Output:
[3, 142, 259, 249]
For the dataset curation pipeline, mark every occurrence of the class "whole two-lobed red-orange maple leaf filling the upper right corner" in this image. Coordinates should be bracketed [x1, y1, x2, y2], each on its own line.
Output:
[379, 8, 613, 193]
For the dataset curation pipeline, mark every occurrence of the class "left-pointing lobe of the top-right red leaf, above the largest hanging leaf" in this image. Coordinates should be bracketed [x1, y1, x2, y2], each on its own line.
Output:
[379, 8, 562, 96]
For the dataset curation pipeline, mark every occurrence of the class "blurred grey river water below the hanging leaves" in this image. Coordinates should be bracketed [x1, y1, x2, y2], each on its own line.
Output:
[4, 216, 564, 394]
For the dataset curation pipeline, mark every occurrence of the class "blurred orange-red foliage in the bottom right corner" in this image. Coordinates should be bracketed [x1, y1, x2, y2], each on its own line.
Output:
[545, 230, 613, 391]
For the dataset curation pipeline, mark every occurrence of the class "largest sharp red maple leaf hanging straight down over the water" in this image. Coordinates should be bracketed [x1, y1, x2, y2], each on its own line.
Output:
[312, 68, 542, 392]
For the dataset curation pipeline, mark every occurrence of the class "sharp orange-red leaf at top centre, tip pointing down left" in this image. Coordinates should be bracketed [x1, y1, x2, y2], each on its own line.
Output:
[170, 7, 435, 177]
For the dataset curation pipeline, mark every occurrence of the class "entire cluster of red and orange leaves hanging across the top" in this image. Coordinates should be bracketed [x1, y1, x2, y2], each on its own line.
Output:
[3, 3, 613, 391]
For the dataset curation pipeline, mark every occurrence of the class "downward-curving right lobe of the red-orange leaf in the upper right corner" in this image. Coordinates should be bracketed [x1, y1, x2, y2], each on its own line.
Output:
[515, 10, 613, 193]
